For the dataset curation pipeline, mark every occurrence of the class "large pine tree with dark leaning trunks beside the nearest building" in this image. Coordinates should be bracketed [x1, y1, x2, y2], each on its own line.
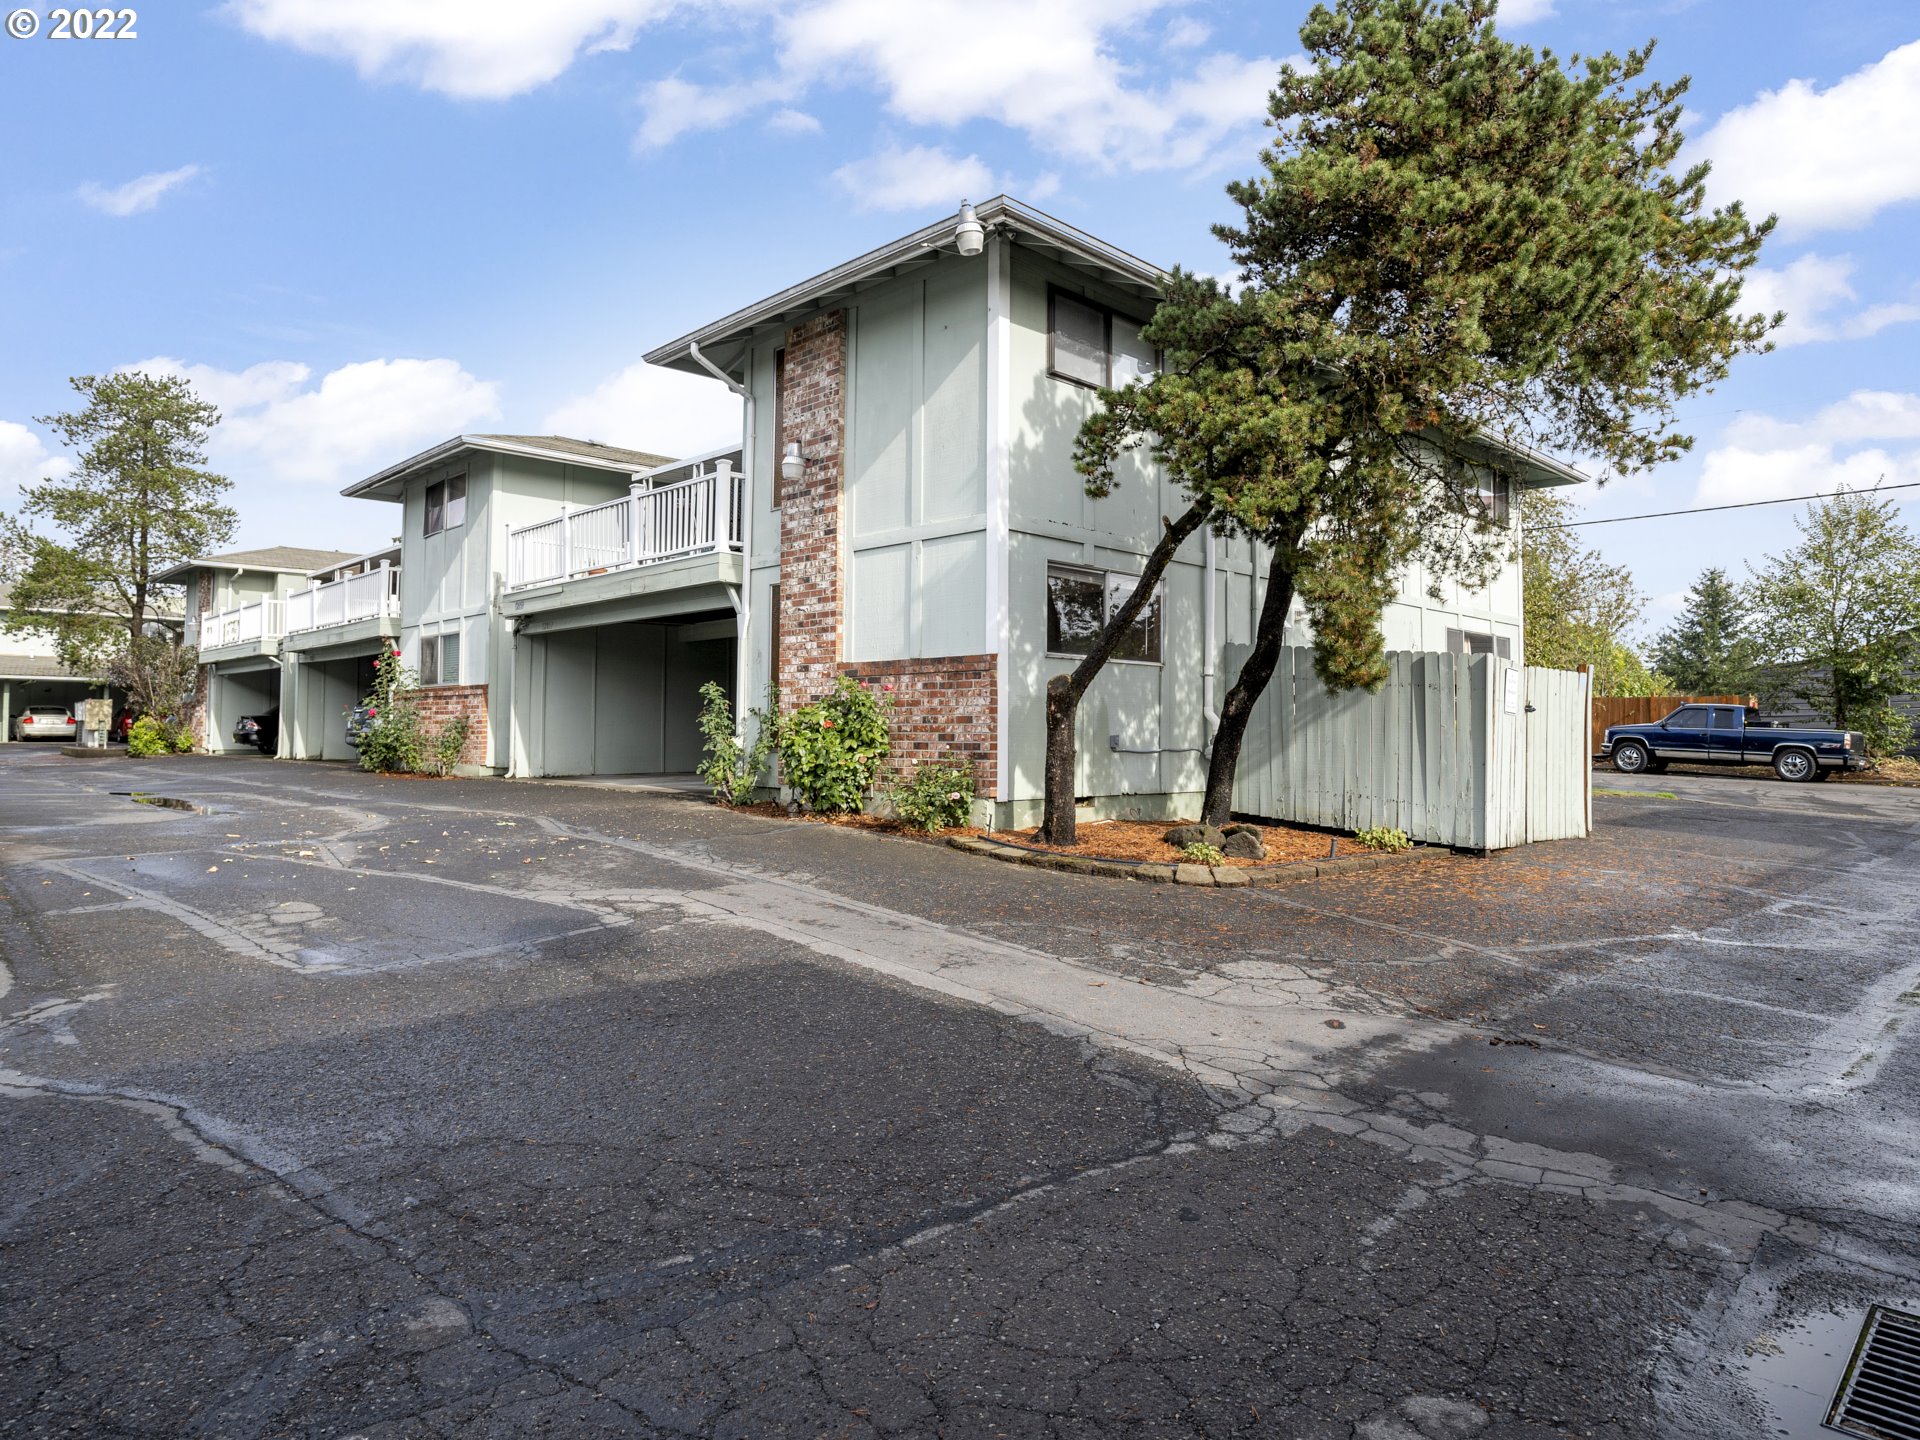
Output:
[1067, 0, 1780, 841]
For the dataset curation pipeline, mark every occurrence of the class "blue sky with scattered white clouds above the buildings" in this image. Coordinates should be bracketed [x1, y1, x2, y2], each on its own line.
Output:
[0, 0, 1920, 637]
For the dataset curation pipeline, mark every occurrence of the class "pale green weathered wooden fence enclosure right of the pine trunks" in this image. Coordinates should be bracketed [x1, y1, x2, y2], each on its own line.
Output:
[1233, 645, 1592, 851]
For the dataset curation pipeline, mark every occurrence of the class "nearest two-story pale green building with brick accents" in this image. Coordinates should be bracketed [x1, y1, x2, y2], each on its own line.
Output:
[647, 198, 1580, 824]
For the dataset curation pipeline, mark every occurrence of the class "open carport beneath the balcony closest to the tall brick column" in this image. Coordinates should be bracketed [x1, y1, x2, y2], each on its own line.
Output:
[515, 612, 737, 776]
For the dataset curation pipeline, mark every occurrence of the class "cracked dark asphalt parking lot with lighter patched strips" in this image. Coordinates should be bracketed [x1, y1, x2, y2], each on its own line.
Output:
[0, 747, 1920, 1440]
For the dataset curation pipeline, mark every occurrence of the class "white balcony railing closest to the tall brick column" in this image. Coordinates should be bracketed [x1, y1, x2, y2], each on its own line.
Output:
[507, 459, 747, 589]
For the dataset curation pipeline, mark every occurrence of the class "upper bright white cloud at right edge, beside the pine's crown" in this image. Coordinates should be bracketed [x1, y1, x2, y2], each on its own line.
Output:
[1699, 40, 1920, 232]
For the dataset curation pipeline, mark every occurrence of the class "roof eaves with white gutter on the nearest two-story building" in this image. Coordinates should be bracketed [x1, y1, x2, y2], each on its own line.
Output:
[645, 196, 1167, 374]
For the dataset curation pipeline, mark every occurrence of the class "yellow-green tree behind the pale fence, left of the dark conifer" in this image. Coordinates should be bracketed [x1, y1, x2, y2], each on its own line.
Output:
[1521, 490, 1661, 695]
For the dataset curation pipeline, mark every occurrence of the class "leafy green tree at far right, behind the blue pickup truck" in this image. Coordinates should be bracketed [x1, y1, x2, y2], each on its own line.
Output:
[1749, 493, 1920, 755]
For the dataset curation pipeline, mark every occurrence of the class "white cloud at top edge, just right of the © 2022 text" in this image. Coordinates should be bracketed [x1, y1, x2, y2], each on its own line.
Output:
[227, 0, 674, 100]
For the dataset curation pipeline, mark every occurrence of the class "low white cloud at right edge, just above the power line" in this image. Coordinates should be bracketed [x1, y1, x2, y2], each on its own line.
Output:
[1695, 390, 1920, 505]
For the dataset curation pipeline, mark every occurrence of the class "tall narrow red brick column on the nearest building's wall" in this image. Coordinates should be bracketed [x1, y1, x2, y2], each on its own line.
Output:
[774, 311, 847, 707]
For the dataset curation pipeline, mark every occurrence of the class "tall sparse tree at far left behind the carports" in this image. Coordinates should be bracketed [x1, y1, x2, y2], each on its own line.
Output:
[0, 372, 234, 674]
